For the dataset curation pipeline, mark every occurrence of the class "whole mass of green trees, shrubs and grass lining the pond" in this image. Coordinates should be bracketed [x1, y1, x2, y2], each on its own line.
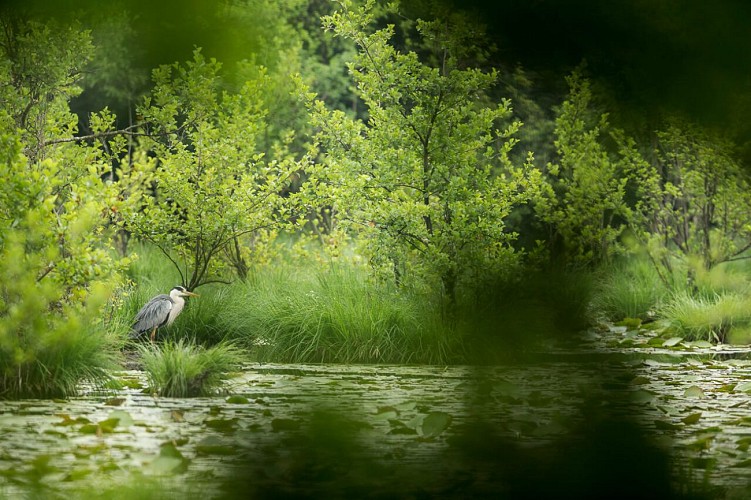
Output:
[0, 0, 751, 396]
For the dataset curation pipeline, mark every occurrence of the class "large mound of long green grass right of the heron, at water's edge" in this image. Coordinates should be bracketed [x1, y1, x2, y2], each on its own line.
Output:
[226, 265, 456, 363]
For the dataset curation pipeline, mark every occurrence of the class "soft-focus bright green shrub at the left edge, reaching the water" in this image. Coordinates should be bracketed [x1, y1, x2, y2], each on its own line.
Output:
[0, 215, 119, 398]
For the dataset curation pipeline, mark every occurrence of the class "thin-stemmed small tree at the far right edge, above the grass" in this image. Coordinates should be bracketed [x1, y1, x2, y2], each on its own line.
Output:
[615, 119, 751, 290]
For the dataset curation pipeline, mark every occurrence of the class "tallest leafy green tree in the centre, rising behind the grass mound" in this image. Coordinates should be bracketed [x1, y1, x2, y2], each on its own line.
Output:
[306, 1, 540, 304]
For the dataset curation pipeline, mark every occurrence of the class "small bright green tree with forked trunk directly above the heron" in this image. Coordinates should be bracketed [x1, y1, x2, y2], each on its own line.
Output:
[128, 49, 299, 289]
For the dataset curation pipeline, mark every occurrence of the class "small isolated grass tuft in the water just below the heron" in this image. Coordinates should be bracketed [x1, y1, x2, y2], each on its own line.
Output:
[138, 339, 241, 397]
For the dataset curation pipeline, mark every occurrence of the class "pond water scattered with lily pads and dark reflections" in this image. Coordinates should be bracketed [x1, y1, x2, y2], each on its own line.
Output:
[0, 332, 751, 499]
